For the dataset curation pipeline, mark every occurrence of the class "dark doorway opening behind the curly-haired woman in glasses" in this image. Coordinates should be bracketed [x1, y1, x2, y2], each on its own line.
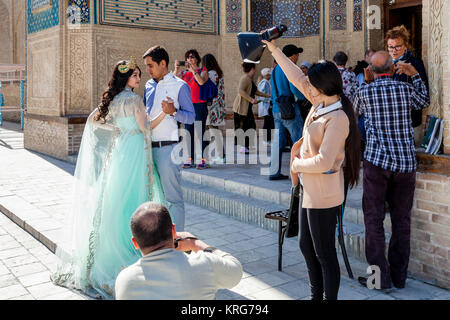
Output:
[384, 0, 422, 58]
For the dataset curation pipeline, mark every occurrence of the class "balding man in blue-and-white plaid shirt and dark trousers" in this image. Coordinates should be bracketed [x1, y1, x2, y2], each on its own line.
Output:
[354, 51, 430, 289]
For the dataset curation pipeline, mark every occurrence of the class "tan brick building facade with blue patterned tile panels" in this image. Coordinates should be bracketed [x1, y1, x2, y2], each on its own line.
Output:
[0, 0, 450, 288]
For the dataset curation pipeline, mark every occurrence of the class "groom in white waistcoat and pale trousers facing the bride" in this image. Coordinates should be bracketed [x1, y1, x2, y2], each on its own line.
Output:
[143, 46, 195, 231]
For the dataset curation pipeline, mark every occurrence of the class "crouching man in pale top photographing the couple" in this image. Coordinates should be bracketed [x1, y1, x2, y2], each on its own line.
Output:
[115, 202, 242, 300]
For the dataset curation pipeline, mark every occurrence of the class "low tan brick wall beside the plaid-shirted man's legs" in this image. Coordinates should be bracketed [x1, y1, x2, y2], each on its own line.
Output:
[409, 172, 450, 289]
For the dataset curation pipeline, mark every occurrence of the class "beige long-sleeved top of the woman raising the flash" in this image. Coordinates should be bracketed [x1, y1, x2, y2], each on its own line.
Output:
[272, 48, 350, 209]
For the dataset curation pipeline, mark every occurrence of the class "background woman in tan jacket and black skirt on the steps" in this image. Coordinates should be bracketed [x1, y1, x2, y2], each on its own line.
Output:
[233, 62, 270, 154]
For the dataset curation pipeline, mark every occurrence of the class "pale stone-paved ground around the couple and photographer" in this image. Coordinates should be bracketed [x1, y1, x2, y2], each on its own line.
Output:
[0, 122, 450, 300]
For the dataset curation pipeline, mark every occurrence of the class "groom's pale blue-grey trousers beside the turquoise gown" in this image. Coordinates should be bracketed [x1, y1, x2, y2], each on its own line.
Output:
[152, 144, 185, 231]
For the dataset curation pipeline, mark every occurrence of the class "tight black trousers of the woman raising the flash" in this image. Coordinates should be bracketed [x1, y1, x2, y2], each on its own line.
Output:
[299, 202, 342, 300]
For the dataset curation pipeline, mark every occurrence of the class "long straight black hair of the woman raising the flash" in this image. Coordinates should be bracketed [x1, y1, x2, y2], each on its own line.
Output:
[308, 61, 361, 187]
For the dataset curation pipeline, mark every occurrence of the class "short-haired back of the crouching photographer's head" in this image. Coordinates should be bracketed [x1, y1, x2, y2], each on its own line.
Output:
[130, 202, 172, 249]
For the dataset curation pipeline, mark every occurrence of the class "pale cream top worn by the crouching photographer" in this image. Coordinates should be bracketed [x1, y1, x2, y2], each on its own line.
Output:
[115, 249, 242, 300]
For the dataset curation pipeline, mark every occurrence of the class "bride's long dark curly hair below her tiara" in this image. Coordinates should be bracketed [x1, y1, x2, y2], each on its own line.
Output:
[94, 60, 141, 121]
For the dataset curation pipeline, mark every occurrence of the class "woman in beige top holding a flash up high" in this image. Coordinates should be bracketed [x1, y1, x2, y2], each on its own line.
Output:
[263, 41, 361, 300]
